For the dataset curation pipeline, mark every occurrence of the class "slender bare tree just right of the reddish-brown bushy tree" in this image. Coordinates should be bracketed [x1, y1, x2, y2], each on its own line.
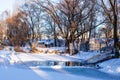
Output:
[21, 0, 42, 41]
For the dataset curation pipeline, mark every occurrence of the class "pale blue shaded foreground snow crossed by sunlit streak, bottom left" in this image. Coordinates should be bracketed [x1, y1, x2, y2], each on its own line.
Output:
[0, 67, 107, 80]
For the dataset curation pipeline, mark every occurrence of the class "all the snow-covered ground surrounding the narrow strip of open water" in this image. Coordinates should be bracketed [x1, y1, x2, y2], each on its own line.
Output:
[0, 48, 120, 80]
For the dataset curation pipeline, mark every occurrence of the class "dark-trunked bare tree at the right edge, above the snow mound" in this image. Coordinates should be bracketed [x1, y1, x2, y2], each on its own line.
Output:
[101, 0, 120, 58]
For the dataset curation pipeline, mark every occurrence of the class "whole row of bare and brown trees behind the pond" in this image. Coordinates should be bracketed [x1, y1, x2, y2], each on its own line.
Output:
[0, 0, 120, 57]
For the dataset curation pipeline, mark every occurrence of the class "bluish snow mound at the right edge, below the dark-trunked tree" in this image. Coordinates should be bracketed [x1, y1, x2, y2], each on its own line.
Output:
[99, 59, 120, 76]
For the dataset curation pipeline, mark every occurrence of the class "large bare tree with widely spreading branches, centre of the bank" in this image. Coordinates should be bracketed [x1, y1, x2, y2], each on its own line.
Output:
[34, 0, 103, 55]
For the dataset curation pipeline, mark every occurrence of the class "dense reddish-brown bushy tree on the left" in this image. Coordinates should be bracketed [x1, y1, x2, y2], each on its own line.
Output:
[6, 11, 29, 46]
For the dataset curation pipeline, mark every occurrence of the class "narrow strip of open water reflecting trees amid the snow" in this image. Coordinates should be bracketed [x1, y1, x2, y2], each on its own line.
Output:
[14, 61, 81, 68]
